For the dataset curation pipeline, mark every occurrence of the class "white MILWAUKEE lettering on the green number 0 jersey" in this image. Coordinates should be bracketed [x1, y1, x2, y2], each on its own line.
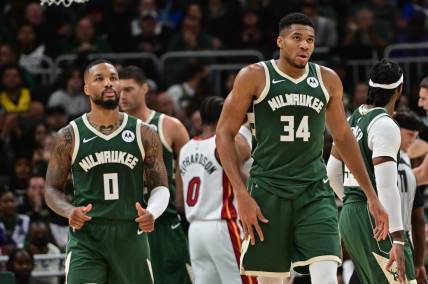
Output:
[79, 151, 138, 172]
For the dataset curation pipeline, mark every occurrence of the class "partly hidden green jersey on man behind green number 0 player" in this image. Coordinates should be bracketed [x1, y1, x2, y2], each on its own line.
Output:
[146, 110, 177, 214]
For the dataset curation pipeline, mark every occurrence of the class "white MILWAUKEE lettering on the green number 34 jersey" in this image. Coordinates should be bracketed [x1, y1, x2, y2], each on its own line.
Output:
[268, 94, 324, 113]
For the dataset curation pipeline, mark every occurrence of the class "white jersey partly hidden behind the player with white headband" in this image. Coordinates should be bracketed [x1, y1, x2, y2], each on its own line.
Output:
[398, 151, 416, 231]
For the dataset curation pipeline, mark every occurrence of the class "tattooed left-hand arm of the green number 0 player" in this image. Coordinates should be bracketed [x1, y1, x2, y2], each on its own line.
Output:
[45, 125, 92, 229]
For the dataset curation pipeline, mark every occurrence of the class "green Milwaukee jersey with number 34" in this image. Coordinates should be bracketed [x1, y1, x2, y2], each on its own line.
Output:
[248, 60, 329, 198]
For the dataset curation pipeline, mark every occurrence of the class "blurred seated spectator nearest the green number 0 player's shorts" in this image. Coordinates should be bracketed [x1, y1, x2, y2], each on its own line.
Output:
[28, 222, 61, 284]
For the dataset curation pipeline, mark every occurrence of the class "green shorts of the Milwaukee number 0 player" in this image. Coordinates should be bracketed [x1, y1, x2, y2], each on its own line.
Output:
[65, 219, 153, 284]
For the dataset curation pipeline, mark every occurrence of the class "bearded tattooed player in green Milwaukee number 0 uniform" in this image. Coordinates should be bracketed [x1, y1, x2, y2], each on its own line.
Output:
[45, 59, 169, 284]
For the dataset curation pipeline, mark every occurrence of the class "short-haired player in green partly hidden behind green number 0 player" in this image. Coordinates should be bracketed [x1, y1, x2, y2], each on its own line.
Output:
[119, 66, 190, 284]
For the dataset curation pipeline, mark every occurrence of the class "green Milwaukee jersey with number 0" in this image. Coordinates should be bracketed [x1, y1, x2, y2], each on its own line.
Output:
[70, 114, 144, 220]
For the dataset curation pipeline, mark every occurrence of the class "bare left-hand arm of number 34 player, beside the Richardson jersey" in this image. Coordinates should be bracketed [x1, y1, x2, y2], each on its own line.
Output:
[216, 64, 267, 244]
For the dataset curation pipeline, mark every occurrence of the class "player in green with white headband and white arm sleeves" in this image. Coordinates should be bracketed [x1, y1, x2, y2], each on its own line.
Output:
[327, 59, 415, 284]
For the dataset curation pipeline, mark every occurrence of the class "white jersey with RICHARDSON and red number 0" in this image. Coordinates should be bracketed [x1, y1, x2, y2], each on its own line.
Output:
[179, 136, 237, 222]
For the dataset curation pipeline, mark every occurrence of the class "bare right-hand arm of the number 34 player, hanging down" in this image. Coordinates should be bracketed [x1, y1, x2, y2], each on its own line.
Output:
[321, 67, 389, 239]
